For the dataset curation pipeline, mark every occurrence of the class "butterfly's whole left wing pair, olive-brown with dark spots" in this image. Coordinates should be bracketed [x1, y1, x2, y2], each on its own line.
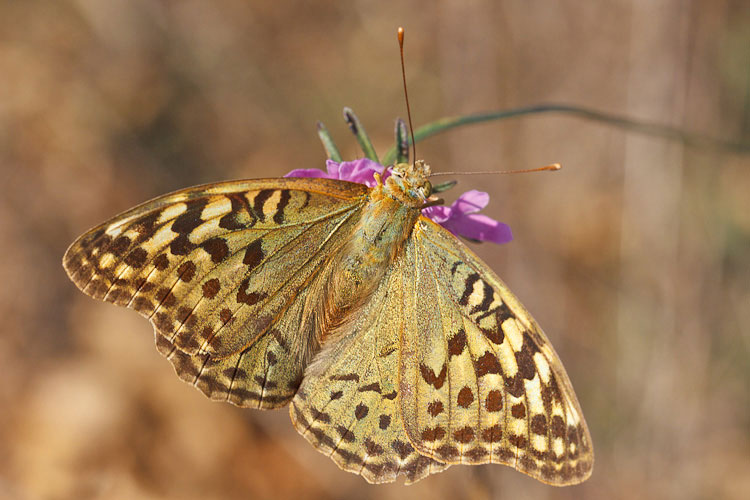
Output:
[63, 178, 368, 408]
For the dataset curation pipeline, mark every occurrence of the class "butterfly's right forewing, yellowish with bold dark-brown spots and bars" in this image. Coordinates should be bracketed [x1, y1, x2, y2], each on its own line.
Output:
[398, 217, 593, 485]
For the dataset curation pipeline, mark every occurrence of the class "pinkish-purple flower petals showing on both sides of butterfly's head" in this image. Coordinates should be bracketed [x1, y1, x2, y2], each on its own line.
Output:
[284, 158, 513, 244]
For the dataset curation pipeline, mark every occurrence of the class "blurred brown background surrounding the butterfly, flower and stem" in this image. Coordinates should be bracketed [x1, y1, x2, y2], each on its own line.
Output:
[0, 0, 750, 499]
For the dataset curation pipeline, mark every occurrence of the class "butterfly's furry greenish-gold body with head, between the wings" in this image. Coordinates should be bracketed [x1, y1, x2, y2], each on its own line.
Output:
[323, 161, 431, 335]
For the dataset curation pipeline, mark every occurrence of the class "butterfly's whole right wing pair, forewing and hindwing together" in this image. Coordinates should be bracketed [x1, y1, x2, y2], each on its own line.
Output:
[290, 218, 593, 485]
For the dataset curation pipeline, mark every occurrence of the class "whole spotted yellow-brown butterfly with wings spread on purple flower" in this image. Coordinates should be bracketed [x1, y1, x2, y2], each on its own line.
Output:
[63, 130, 593, 486]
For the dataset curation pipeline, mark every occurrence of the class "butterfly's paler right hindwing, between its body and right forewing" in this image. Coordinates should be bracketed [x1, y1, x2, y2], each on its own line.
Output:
[290, 250, 448, 484]
